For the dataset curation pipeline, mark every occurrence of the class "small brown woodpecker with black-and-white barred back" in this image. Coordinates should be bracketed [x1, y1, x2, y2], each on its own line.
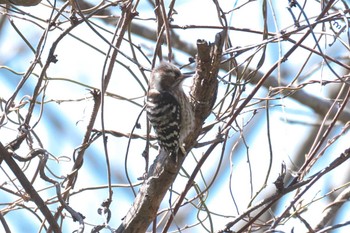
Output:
[146, 62, 194, 157]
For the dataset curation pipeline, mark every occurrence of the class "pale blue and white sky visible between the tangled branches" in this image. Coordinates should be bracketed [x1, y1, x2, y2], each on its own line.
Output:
[0, 0, 350, 232]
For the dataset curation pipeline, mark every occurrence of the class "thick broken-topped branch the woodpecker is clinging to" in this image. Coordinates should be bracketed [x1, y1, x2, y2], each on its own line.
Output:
[115, 31, 226, 233]
